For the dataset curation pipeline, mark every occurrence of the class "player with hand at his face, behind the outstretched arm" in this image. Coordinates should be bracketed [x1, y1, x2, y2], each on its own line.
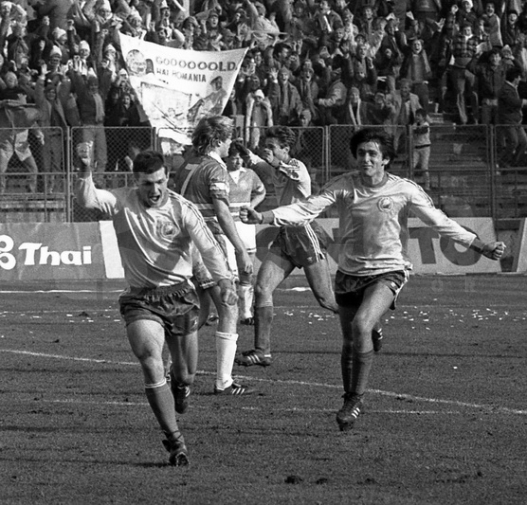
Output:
[236, 126, 338, 366]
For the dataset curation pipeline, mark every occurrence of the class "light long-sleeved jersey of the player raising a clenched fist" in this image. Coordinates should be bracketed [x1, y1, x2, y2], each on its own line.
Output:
[77, 176, 232, 288]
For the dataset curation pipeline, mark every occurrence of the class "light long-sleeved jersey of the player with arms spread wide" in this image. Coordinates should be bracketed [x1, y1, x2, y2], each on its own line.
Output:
[264, 173, 476, 275]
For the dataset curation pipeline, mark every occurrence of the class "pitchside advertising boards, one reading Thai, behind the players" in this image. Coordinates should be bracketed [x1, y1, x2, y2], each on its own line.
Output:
[0, 218, 508, 281]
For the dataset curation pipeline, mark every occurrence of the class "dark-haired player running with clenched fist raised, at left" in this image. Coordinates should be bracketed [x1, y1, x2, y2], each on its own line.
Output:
[77, 143, 237, 466]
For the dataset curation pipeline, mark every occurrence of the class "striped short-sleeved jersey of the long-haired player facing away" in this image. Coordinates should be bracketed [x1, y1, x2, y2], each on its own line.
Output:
[174, 154, 229, 234]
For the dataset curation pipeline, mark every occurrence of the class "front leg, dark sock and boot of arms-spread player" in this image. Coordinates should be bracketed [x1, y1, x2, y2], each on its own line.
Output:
[337, 283, 395, 430]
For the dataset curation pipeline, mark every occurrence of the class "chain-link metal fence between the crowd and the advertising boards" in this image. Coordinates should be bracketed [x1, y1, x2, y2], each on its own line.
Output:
[0, 124, 527, 223]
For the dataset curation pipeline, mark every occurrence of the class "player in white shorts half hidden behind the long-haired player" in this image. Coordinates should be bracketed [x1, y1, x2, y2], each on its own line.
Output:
[225, 141, 265, 325]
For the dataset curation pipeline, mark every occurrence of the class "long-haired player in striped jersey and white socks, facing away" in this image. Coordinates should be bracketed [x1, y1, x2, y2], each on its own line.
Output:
[174, 116, 254, 396]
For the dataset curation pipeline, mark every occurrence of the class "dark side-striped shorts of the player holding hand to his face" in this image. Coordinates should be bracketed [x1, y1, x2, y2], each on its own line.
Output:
[269, 223, 330, 268]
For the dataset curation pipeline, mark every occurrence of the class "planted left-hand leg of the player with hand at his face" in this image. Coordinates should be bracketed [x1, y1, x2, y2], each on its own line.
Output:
[236, 251, 295, 366]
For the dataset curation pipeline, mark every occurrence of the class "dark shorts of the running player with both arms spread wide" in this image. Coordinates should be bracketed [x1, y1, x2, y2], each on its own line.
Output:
[335, 270, 409, 310]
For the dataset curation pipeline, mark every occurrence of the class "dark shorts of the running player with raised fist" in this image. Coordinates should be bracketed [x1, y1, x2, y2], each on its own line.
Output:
[119, 282, 199, 336]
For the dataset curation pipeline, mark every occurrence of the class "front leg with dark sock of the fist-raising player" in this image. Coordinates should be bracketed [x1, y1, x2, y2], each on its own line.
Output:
[126, 319, 188, 466]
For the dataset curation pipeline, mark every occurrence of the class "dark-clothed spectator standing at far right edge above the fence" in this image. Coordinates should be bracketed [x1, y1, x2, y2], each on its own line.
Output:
[498, 67, 527, 167]
